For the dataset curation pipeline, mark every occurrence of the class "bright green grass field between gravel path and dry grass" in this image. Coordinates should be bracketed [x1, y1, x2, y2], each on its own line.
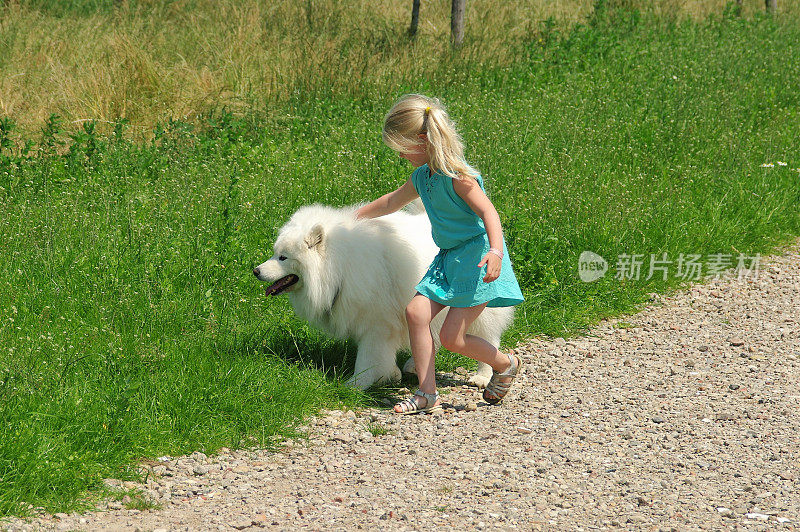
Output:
[0, 1, 800, 515]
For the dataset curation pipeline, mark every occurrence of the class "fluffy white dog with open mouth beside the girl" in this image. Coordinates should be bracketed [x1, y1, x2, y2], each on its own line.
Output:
[253, 200, 514, 388]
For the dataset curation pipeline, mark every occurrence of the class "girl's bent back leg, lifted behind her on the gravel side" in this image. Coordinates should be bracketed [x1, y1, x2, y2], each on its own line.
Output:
[439, 303, 511, 400]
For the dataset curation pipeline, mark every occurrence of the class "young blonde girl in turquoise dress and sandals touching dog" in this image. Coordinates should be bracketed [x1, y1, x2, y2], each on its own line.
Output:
[356, 94, 523, 414]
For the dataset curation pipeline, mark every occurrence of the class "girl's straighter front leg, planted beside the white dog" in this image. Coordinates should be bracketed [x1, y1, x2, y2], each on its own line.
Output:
[395, 292, 445, 412]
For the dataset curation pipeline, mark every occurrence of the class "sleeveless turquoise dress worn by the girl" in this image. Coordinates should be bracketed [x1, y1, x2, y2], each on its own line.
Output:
[411, 164, 524, 307]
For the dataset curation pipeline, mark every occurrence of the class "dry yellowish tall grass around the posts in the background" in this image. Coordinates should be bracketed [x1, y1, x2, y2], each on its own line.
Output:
[0, 0, 800, 135]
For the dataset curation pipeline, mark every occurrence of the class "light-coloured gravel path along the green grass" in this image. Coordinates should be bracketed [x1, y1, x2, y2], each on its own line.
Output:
[4, 241, 800, 531]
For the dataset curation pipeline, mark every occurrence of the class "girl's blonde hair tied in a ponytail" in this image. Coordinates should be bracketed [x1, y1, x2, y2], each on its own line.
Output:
[383, 94, 478, 179]
